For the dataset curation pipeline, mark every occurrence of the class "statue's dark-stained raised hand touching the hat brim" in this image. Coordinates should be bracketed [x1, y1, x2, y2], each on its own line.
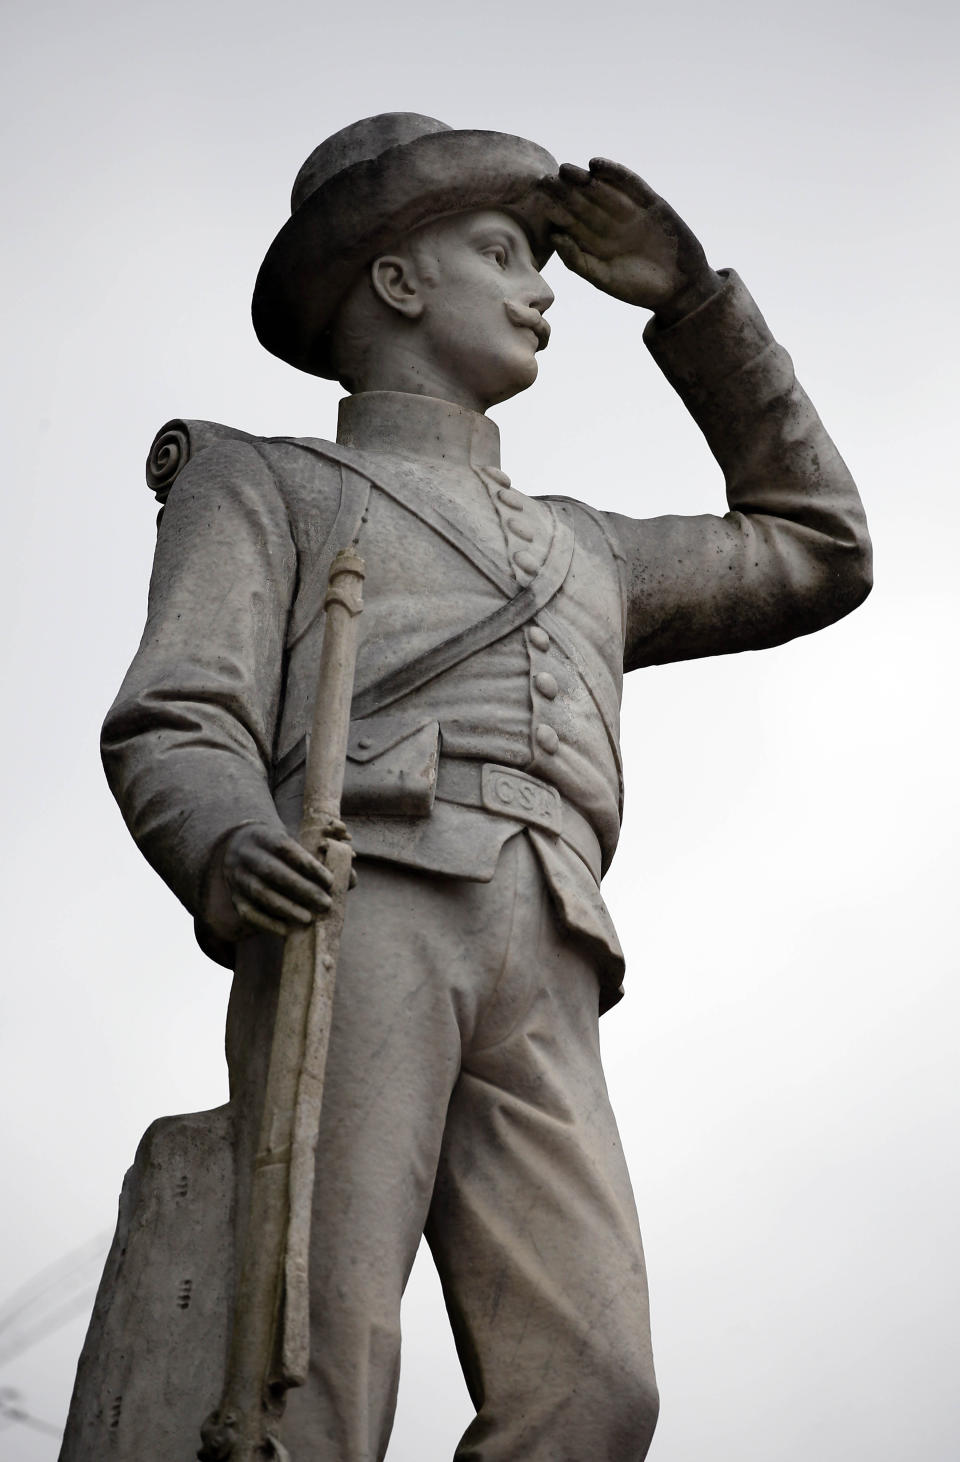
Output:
[541, 158, 723, 323]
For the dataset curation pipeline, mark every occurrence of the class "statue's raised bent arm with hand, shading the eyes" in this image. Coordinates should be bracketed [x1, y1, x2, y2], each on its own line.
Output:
[545, 159, 871, 670]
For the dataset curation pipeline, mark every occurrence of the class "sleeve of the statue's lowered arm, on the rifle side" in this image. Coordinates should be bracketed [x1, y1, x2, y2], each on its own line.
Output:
[102, 442, 297, 915]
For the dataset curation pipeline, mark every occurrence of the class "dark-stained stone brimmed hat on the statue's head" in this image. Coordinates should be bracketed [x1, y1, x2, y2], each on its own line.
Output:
[253, 111, 557, 377]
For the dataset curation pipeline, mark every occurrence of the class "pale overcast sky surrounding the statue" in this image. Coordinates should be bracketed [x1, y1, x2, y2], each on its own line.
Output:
[0, 0, 960, 1462]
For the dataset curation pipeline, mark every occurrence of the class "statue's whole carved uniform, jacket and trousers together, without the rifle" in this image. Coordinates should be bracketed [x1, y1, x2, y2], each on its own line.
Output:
[95, 275, 868, 1462]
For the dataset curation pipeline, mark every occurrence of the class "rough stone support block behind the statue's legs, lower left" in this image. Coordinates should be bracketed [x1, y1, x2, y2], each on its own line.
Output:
[60, 1107, 234, 1462]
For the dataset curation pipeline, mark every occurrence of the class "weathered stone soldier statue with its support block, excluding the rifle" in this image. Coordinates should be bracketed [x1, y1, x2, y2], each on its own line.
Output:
[63, 114, 869, 1462]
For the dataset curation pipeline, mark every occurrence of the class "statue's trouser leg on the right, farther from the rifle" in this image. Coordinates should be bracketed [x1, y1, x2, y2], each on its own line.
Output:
[427, 841, 658, 1462]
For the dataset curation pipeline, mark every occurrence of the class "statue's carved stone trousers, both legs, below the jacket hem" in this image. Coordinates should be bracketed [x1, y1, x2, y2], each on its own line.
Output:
[228, 833, 658, 1462]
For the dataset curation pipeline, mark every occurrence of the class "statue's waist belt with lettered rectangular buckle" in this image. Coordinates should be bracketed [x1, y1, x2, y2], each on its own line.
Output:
[437, 756, 602, 883]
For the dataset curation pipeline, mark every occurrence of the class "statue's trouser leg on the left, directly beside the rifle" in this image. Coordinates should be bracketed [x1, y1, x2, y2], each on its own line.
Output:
[273, 839, 555, 1462]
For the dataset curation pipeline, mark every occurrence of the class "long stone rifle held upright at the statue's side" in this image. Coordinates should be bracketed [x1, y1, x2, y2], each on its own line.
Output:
[197, 548, 364, 1462]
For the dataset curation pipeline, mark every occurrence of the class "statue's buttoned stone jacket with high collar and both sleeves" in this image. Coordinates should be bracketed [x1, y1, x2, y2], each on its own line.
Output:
[104, 275, 869, 1003]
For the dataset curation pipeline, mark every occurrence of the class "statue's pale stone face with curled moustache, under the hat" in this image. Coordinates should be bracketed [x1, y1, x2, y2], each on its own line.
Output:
[411, 209, 554, 411]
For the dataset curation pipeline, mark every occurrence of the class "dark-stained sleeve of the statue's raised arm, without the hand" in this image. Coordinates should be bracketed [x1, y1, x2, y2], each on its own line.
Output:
[608, 273, 871, 670]
